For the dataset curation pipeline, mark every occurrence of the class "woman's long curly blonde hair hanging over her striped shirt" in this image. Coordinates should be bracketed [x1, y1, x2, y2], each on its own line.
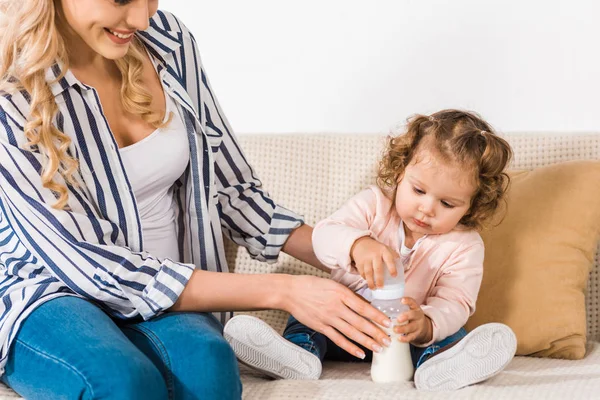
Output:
[0, 0, 172, 209]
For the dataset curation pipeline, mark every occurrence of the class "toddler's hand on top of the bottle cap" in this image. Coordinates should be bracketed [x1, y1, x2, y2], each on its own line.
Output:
[350, 236, 398, 289]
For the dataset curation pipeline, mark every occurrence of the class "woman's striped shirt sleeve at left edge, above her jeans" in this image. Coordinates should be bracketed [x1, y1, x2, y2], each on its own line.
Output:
[0, 102, 194, 319]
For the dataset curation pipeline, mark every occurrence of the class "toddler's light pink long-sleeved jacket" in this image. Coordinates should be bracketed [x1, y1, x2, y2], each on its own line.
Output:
[312, 186, 484, 346]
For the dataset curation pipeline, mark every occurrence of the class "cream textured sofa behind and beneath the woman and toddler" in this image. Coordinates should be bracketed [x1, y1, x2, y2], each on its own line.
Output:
[0, 133, 600, 400]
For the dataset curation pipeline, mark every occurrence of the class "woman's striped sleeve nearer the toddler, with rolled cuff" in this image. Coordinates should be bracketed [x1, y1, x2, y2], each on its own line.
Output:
[181, 25, 304, 262]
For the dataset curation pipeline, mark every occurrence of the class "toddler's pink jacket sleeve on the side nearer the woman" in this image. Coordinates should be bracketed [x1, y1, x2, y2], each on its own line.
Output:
[312, 188, 377, 274]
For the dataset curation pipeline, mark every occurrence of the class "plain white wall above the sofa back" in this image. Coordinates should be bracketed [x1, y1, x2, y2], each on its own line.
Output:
[160, 0, 600, 133]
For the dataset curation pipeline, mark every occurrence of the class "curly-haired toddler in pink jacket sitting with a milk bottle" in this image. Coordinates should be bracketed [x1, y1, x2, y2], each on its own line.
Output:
[225, 110, 517, 390]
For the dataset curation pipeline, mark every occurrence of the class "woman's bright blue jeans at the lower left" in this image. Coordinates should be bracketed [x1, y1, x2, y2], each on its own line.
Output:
[2, 296, 242, 400]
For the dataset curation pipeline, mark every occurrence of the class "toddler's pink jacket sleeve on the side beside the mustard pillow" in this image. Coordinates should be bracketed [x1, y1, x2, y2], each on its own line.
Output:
[418, 241, 484, 347]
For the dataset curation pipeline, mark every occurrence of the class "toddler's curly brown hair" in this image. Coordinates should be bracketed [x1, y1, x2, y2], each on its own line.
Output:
[377, 110, 512, 229]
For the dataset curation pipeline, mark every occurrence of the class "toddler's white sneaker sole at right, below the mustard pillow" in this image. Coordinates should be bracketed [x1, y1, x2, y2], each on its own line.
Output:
[414, 323, 517, 391]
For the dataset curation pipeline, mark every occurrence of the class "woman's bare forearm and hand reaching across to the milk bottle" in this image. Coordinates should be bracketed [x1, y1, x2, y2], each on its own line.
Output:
[171, 270, 389, 358]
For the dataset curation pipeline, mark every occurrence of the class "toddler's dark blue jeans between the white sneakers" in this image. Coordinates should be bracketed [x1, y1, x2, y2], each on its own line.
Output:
[283, 316, 467, 369]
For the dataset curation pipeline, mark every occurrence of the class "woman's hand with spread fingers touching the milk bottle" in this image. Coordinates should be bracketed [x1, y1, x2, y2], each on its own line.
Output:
[283, 275, 390, 359]
